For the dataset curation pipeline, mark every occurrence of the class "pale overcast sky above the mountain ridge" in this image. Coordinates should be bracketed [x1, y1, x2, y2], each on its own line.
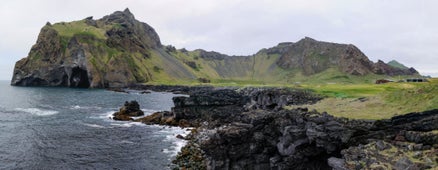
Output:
[0, 0, 438, 80]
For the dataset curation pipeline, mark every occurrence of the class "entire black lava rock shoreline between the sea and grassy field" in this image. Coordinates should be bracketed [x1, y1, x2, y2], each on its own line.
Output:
[112, 88, 438, 169]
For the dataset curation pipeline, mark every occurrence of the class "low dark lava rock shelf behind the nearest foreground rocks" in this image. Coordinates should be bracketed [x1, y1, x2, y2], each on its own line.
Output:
[136, 87, 321, 127]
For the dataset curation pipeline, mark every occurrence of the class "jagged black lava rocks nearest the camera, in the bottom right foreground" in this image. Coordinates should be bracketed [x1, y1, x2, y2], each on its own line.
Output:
[193, 110, 438, 169]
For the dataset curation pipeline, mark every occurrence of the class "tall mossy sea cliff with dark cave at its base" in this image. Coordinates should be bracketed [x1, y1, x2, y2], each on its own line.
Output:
[11, 9, 193, 87]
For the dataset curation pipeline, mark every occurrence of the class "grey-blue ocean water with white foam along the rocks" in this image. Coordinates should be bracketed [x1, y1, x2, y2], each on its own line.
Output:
[0, 81, 188, 169]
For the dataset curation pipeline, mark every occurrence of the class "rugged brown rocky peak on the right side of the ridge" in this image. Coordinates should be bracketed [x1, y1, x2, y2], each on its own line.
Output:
[276, 37, 418, 76]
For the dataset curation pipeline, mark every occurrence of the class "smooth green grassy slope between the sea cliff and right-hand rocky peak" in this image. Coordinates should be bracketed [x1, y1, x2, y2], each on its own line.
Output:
[140, 49, 403, 86]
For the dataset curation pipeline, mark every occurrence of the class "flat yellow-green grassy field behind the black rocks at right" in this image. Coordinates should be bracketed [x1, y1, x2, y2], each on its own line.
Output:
[290, 79, 438, 119]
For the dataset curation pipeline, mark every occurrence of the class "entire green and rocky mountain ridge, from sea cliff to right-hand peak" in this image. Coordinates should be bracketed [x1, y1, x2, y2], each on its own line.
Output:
[11, 9, 418, 88]
